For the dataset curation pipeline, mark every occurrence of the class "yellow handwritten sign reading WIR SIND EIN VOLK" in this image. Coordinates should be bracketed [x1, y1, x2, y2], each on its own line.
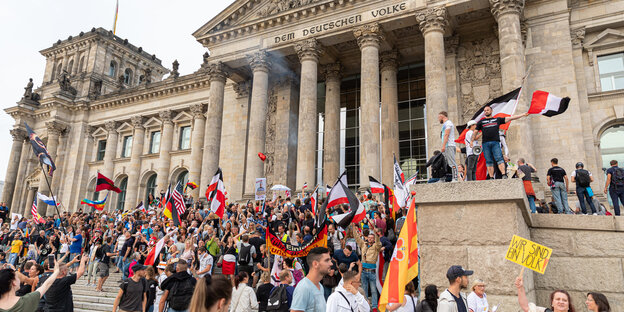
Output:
[505, 235, 552, 274]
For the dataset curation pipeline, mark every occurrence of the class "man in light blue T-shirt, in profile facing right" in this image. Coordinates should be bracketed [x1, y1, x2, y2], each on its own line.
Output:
[290, 247, 332, 312]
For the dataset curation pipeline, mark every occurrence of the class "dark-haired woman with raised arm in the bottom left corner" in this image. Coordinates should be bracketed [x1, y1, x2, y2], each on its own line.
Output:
[0, 265, 60, 312]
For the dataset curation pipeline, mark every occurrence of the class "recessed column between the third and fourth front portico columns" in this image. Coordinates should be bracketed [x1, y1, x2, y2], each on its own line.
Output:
[323, 63, 342, 185]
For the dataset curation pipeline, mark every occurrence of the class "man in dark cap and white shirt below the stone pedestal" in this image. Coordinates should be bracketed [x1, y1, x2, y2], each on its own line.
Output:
[437, 265, 474, 312]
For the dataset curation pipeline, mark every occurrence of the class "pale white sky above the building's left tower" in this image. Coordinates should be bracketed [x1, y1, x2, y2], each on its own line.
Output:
[0, 0, 234, 181]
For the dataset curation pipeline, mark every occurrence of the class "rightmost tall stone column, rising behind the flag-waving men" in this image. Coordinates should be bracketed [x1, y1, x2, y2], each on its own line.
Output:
[490, 0, 534, 159]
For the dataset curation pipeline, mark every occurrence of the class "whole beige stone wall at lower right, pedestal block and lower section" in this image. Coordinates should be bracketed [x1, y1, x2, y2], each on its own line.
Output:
[412, 179, 624, 312]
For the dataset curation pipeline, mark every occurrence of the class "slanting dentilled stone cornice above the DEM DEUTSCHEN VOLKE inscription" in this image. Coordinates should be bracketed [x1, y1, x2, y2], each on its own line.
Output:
[193, 0, 367, 47]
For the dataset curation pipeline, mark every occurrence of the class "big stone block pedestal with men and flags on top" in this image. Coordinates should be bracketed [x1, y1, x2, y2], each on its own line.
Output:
[412, 179, 535, 310]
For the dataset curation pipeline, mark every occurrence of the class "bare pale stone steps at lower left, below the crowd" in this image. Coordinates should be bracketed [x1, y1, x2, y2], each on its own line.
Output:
[72, 268, 121, 312]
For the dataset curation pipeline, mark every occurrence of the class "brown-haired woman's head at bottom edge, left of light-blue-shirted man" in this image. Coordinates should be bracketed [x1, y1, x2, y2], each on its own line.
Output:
[189, 275, 232, 312]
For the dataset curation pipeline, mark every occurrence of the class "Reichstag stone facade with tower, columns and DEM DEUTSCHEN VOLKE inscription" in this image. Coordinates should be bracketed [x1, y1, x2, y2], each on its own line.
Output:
[2, 0, 624, 213]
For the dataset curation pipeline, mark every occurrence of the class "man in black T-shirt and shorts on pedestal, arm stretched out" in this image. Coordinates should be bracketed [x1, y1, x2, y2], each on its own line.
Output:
[473, 106, 529, 179]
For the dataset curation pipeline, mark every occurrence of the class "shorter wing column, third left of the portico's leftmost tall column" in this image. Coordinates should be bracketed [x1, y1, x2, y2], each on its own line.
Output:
[124, 116, 149, 210]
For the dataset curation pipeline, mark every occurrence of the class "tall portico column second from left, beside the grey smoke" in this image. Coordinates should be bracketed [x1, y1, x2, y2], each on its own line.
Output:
[244, 50, 271, 196]
